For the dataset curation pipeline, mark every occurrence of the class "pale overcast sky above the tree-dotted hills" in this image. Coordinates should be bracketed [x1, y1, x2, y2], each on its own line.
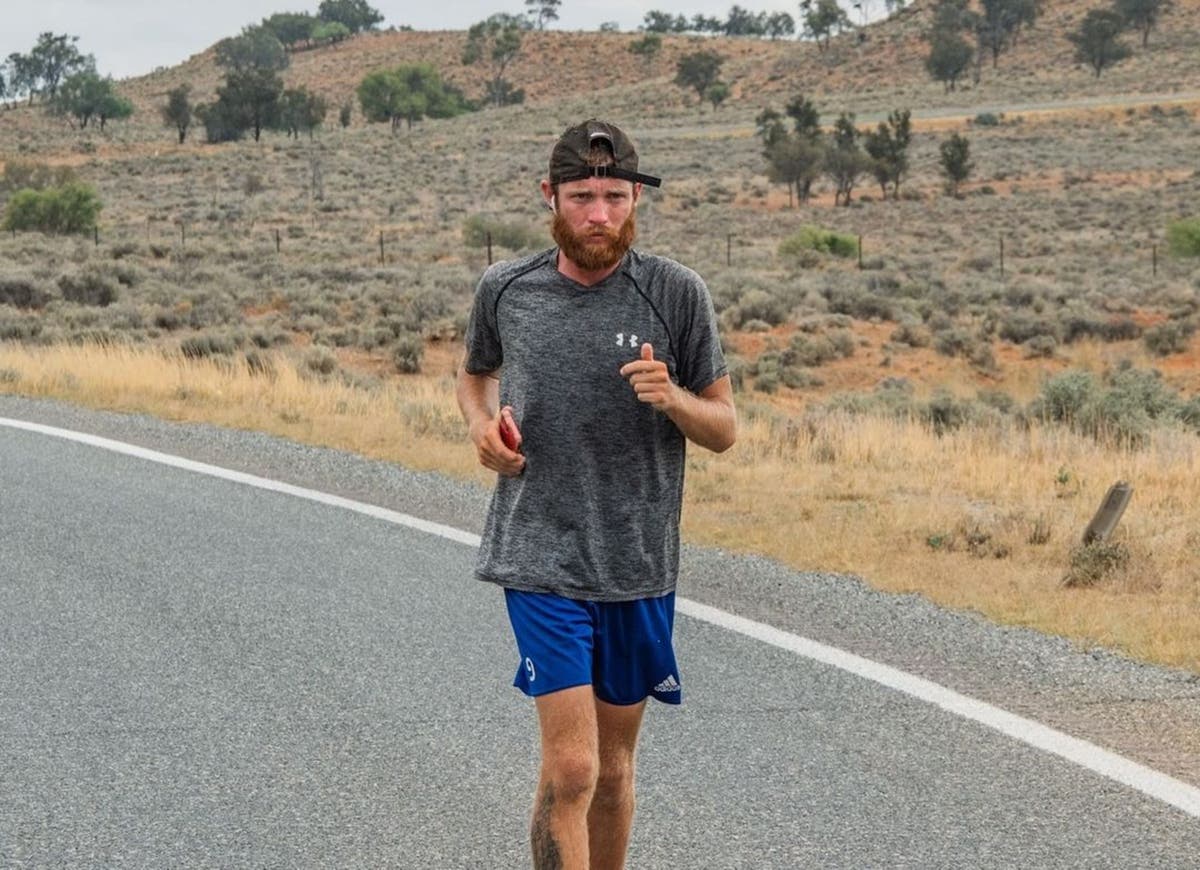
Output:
[0, 0, 882, 78]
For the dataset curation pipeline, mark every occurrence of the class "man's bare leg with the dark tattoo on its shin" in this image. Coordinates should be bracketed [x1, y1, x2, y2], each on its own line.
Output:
[529, 685, 600, 870]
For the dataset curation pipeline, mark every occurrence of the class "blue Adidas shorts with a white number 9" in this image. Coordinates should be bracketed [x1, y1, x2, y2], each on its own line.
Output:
[504, 589, 682, 704]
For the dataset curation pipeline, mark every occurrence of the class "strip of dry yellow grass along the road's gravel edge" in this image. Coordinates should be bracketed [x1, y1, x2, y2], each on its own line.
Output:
[0, 344, 1200, 671]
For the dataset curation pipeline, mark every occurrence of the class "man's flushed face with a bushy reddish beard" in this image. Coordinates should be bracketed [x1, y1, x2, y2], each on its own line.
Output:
[551, 178, 641, 271]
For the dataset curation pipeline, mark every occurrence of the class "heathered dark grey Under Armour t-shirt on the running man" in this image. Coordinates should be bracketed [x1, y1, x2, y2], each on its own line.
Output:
[466, 244, 726, 601]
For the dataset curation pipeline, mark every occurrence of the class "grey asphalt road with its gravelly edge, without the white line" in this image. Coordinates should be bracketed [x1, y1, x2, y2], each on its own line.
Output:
[0, 401, 1200, 868]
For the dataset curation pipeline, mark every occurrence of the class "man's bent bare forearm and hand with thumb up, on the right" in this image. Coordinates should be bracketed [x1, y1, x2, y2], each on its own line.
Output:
[620, 343, 738, 454]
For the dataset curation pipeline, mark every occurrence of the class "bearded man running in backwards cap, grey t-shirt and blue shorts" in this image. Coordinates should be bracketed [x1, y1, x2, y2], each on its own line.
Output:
[457, 120, 737, 870]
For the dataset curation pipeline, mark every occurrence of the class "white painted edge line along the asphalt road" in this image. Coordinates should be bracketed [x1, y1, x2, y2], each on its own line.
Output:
[0, 418, 1200, 818]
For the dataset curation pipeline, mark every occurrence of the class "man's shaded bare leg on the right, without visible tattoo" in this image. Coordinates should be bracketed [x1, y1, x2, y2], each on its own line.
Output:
[588, 698, 646, 870]
